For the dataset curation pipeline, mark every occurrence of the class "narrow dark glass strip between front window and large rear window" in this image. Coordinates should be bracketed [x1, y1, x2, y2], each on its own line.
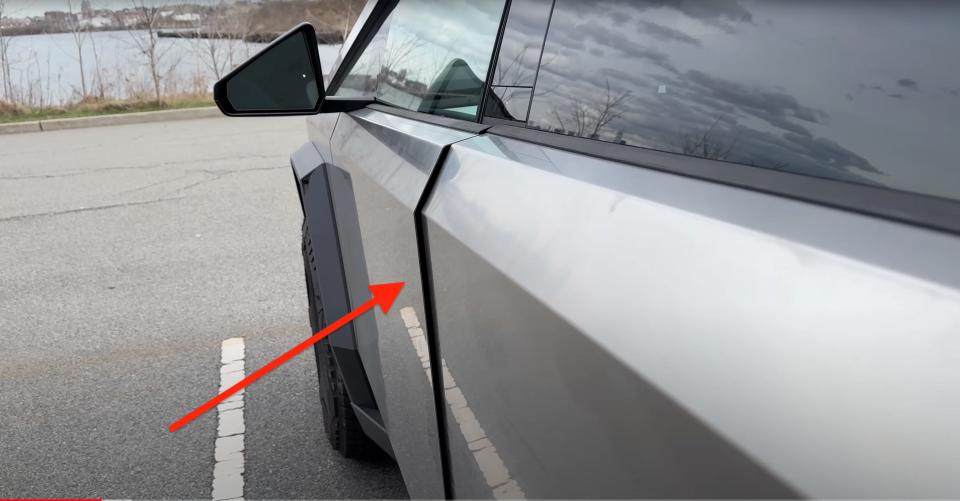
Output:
[484, 0, 553, 122]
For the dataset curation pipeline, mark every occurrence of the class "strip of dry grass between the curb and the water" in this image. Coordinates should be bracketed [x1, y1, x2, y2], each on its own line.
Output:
[0, 95, 213, 123]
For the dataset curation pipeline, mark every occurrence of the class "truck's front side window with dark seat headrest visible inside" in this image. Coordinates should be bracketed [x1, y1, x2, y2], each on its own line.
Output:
[335, 0, 506, 120]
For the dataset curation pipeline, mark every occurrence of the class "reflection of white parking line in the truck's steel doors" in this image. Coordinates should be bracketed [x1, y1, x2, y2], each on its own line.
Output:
[400, 306, 525, 499]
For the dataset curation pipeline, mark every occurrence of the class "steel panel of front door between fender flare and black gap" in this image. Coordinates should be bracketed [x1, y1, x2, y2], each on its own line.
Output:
[329, 110, 472, 498]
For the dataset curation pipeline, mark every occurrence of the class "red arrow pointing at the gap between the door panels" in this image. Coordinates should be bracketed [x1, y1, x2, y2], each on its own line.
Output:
[169, 282, 403, 432]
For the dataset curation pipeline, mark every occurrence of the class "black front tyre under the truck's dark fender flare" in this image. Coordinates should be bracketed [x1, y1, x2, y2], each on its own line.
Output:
[302, 229, 379, 458]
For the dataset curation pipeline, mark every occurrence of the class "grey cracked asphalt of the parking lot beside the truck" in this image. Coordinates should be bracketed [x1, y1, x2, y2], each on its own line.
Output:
[0, 118, 407, 499]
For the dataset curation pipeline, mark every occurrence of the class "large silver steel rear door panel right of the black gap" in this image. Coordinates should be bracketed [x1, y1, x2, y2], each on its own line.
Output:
[425, 136, 960, 498]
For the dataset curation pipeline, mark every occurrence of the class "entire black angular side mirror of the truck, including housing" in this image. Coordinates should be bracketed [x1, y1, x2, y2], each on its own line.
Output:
[213, 23, 324, 116]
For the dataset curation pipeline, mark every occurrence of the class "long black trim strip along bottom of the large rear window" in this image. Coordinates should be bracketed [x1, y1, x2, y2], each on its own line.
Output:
[485, 123, 960, 234]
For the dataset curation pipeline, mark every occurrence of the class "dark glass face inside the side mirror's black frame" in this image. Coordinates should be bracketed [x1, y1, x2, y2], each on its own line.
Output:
[225, 27, 321, 113]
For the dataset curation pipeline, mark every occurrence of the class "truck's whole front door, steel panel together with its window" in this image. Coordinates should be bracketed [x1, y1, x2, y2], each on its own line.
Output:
[316, 0, 504, 498]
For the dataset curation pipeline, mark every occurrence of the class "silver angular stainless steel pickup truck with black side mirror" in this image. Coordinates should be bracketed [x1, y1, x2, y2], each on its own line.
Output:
[215, 0, 960, 498]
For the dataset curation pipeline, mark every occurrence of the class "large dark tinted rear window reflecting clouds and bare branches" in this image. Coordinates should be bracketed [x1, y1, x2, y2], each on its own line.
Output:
[528, 0, 960, 199]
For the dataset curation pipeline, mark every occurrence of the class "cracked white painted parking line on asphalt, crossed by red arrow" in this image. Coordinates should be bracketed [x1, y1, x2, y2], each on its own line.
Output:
[213, 337, 245, 501]
